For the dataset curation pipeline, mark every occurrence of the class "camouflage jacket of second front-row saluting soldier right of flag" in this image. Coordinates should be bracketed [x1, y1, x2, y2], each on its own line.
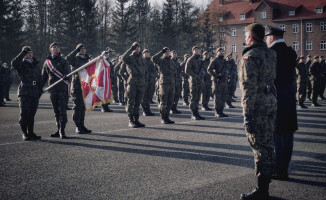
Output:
[152, 51, 177, 85]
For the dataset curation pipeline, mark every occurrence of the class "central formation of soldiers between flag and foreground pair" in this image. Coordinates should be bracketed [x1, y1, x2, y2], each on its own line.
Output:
[107, 43, 237, 128]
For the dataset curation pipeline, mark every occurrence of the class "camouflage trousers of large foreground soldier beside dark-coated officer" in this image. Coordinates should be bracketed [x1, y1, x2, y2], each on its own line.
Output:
[246, 94, 277, 177]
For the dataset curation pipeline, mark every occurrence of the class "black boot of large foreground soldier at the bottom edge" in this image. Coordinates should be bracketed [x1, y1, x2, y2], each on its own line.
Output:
[240, 176, 271, 200]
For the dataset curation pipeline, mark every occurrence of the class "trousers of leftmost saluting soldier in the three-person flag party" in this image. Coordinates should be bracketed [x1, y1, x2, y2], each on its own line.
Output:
[18, 96, 39, 126]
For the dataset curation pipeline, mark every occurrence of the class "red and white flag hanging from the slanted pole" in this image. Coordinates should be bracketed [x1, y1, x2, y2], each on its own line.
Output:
[78, 57, 112, 112]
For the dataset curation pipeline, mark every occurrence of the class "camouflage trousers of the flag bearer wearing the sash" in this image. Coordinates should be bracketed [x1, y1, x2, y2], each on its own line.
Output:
[50, 91, 69, 124]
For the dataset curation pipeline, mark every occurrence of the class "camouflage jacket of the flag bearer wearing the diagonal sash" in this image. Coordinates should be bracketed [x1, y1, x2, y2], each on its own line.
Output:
[42, 55, 70, 93]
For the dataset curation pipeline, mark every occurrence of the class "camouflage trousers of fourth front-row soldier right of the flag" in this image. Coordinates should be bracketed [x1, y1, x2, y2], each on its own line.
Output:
[213, 82, 227, 111]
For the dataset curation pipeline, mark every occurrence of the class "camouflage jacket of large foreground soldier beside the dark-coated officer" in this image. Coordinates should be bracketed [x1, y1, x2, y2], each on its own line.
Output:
[239, 43, 277, 116]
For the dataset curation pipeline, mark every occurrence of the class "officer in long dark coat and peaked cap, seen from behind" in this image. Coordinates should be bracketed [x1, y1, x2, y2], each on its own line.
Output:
[266, 26, 298, 180]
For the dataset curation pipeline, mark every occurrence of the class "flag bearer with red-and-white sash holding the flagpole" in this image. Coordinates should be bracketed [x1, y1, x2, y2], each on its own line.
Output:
[42, 42, 70, 139]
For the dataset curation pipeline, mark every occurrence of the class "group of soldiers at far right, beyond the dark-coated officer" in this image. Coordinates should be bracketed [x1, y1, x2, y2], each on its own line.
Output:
[296, 55, 326, 108]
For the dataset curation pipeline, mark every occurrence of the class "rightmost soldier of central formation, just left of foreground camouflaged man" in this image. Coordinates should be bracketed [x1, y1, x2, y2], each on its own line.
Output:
[226, 54, 237, 108]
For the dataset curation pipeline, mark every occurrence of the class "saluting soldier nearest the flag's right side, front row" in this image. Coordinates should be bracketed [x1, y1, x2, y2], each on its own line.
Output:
[122, 42, 148, 128]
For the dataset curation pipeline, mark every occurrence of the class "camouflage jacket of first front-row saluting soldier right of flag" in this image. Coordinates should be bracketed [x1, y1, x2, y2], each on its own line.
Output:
[122, 48, 148, 86]
